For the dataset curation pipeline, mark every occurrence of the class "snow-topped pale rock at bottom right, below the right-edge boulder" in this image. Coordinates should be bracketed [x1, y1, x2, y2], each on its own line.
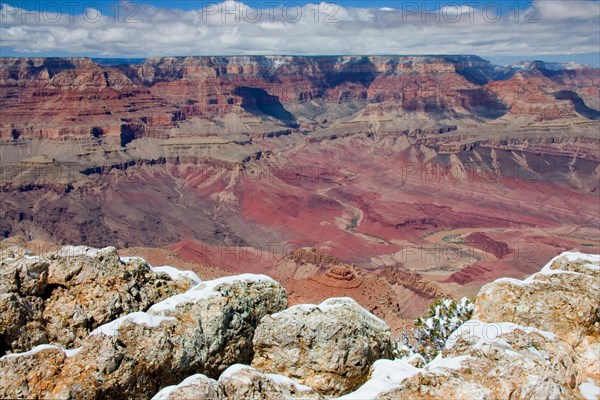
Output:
[377, 320, 577, 400]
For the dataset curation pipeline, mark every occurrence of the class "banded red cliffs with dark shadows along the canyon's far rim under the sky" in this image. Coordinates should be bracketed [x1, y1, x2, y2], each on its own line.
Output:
[0, 56, 598, 139]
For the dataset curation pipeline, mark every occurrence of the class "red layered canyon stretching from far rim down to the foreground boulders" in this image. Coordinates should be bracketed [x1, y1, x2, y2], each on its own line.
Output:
[0, 55, 600, 329]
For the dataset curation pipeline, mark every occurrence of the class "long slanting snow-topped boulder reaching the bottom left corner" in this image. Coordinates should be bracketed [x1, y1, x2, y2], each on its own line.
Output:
[0, 274, 287, 399]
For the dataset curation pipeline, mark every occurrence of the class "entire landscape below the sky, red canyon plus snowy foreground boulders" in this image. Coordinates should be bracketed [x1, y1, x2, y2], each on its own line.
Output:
[0, 49, 600, 400]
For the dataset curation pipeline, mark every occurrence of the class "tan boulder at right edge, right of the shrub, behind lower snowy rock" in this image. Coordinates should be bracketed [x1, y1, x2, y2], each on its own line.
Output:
[474, 253, 600, 383]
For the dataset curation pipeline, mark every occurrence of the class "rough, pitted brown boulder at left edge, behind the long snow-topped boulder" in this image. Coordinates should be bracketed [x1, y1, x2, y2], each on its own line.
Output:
[0, 246, 195, 355]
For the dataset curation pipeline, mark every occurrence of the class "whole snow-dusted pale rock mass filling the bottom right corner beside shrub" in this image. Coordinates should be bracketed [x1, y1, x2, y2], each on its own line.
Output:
[344, 253, 600, 400]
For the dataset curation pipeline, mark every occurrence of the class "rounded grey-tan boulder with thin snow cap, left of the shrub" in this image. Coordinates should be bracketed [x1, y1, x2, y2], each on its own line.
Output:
[252, 298, 392, 396]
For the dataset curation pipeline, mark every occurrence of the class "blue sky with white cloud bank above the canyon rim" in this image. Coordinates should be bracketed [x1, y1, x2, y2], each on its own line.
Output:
[0, 0, 600, 67]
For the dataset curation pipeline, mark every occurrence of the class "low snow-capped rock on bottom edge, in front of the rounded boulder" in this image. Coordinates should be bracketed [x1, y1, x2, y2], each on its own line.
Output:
[152, 364, 323, 400]
